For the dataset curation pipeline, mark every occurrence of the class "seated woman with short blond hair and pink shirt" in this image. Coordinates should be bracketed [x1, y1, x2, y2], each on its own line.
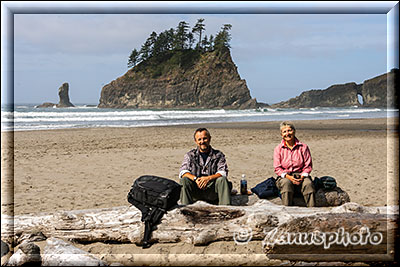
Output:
[274, 121, 315, 207]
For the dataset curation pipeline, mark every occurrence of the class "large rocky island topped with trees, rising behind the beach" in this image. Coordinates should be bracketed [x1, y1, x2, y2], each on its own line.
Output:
[98, 19, 257, 109]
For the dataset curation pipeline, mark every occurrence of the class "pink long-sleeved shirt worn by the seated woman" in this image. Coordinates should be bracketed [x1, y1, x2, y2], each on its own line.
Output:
[274, 138, 312, 176]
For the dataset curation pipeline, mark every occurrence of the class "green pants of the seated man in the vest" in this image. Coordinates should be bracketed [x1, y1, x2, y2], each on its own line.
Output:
[180, 176, 231, 205]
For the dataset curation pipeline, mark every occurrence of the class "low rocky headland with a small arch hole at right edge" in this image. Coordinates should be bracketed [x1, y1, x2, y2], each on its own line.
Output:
[271, 69, 399, 108]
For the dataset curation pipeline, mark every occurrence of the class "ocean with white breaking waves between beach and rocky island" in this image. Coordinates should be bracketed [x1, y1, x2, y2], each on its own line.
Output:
[1, 104, 399, 131]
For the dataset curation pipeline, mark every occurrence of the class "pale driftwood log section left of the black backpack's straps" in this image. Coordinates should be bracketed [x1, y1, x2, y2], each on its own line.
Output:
[1, 206, 142, 246]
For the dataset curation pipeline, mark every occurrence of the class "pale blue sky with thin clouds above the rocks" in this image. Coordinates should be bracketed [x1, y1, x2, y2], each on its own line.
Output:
[2, 1, 398, 104]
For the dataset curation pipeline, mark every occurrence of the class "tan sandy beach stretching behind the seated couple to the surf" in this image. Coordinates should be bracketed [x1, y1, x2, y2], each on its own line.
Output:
[1, 119, 399, 266]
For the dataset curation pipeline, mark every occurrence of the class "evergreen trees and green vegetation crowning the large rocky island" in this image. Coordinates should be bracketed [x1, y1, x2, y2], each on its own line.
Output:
[128, 19, 232, 78]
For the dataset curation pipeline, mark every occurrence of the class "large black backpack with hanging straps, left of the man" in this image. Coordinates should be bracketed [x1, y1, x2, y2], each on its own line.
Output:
[128, 175, 181, 248]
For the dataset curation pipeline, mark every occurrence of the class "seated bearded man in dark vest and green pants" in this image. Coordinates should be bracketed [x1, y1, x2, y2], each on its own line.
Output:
[179, 128, 231, 205]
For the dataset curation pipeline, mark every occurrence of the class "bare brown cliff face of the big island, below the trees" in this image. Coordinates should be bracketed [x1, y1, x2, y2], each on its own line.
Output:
[98, 49, 256, 109]
